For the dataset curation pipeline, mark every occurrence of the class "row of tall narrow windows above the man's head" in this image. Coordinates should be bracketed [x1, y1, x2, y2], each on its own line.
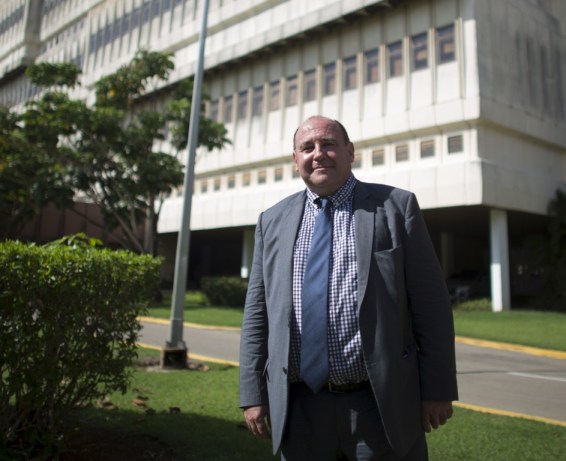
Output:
[208, 24, 456, 123]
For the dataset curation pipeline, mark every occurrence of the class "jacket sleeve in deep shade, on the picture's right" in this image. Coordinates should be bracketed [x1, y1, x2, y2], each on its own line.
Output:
[404, 194, 458, 400]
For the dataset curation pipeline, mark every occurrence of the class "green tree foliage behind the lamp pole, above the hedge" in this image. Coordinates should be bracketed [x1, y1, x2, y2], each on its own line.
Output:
[0, 50, 229, 254]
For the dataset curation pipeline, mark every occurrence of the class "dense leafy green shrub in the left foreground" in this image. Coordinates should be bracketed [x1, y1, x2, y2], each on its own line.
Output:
[0, 239, 160, 459]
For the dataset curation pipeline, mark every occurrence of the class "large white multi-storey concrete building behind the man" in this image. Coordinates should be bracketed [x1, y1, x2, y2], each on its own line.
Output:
[0, 0, 566, 309]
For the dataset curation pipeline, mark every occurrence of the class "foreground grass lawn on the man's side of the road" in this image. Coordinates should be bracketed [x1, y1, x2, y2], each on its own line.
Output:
[66, 349, 566, 461]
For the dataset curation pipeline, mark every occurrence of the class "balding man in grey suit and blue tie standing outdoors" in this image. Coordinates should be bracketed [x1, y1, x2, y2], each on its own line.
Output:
[240, 116, 457, 461]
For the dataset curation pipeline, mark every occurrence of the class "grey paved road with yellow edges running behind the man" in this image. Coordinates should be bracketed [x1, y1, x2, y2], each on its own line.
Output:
[140, 318, 566, 427]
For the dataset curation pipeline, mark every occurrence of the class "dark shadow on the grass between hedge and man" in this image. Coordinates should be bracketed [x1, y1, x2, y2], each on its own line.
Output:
[61, 408, 274, 461]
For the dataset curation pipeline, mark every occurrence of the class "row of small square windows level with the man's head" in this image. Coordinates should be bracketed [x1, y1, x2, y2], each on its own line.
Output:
[195, 134, 464, 194]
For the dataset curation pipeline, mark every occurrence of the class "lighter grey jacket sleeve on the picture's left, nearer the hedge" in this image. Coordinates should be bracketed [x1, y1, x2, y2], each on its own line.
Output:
[240, 214, 268, 407]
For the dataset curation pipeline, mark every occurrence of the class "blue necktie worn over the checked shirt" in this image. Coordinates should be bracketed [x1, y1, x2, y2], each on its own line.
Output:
[301, 198, 332, 393]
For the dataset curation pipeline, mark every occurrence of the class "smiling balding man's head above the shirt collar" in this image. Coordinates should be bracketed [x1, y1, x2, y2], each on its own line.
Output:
[293, 117, 354, 197]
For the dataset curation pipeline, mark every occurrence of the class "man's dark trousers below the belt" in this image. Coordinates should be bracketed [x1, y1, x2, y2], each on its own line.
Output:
[281, 384, 428, 461]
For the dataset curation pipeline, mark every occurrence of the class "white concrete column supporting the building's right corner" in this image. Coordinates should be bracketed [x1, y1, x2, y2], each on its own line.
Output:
[490, 209, 511, 312]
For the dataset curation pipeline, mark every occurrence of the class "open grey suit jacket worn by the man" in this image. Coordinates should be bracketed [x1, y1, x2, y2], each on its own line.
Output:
[240, 182, 458, 456]
